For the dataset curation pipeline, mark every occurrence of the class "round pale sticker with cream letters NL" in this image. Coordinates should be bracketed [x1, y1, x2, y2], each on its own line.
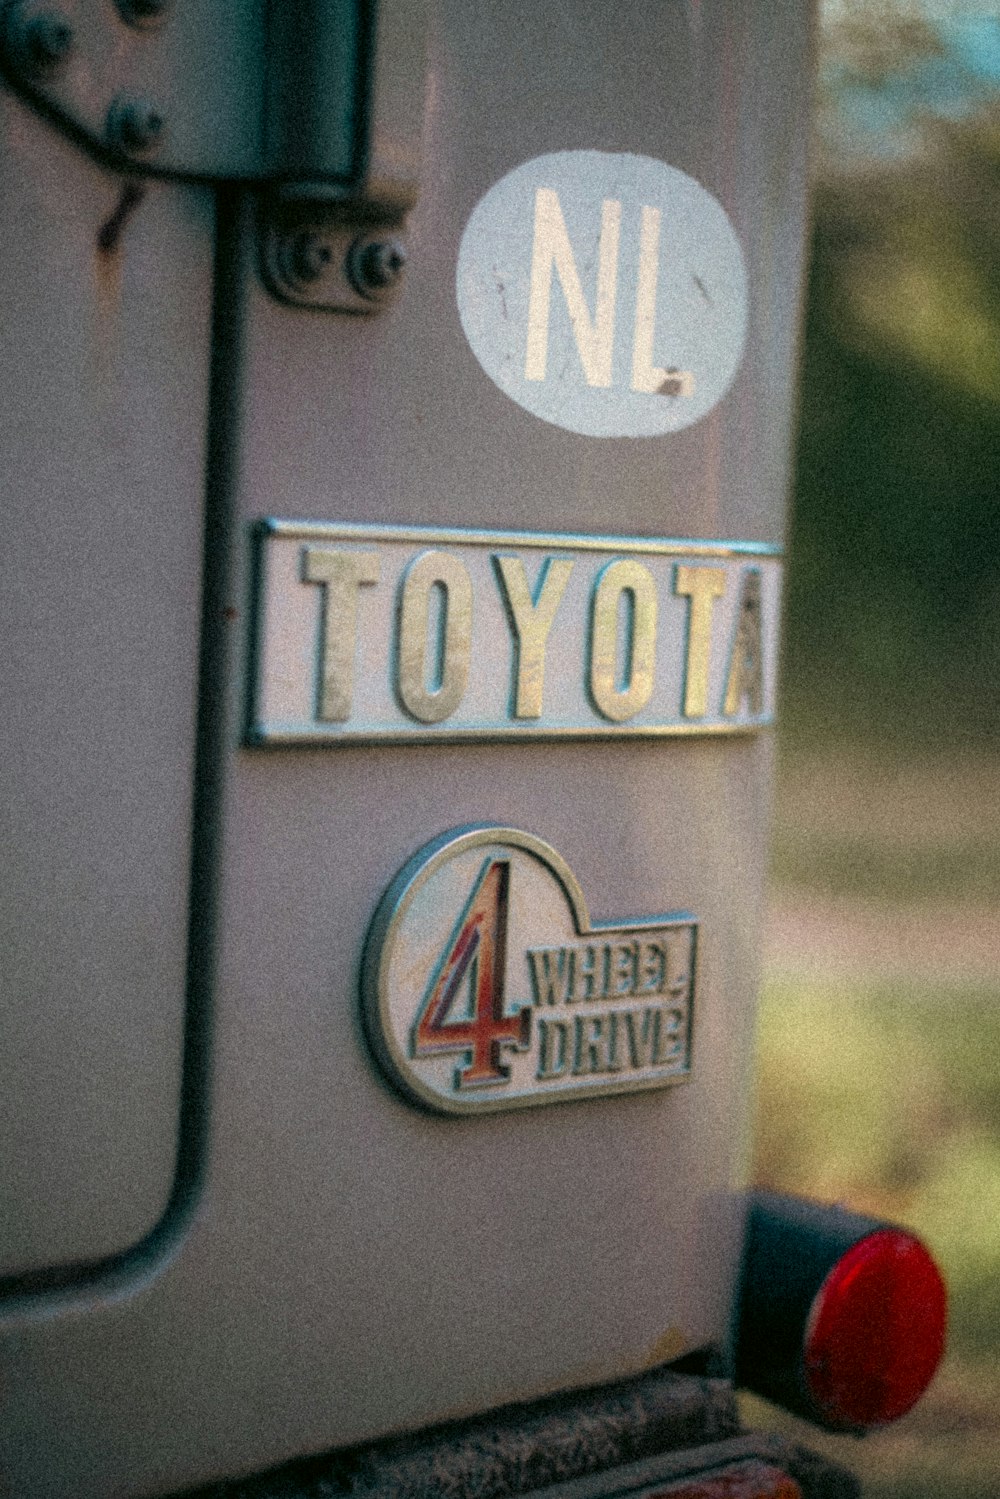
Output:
[456, 151, 747, 438]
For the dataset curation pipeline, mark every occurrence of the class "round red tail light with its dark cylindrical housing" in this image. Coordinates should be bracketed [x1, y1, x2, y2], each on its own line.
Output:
[736, 1193, 946, 1432]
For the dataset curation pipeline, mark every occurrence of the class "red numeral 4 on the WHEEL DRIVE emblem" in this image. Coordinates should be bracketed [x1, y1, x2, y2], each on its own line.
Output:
[412, 859, 531, 1088]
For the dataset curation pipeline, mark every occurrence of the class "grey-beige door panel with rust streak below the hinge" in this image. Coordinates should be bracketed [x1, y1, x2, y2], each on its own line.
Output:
[0, 93, 213, 1277]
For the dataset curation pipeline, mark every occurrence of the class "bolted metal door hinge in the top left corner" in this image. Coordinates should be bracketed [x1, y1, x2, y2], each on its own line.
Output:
[0, 0, 429, 312]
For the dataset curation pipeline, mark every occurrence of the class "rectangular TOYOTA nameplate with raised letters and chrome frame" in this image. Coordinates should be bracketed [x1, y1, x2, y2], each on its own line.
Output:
[247, 520, 781, 745]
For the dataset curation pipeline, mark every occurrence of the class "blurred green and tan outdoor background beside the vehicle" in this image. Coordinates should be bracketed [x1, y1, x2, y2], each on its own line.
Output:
[747, 0, 1000, 1499]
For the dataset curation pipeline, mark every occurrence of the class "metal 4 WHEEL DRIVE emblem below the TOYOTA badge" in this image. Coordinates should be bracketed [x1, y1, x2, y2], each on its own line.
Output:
[361, 827, 696, 1114]
